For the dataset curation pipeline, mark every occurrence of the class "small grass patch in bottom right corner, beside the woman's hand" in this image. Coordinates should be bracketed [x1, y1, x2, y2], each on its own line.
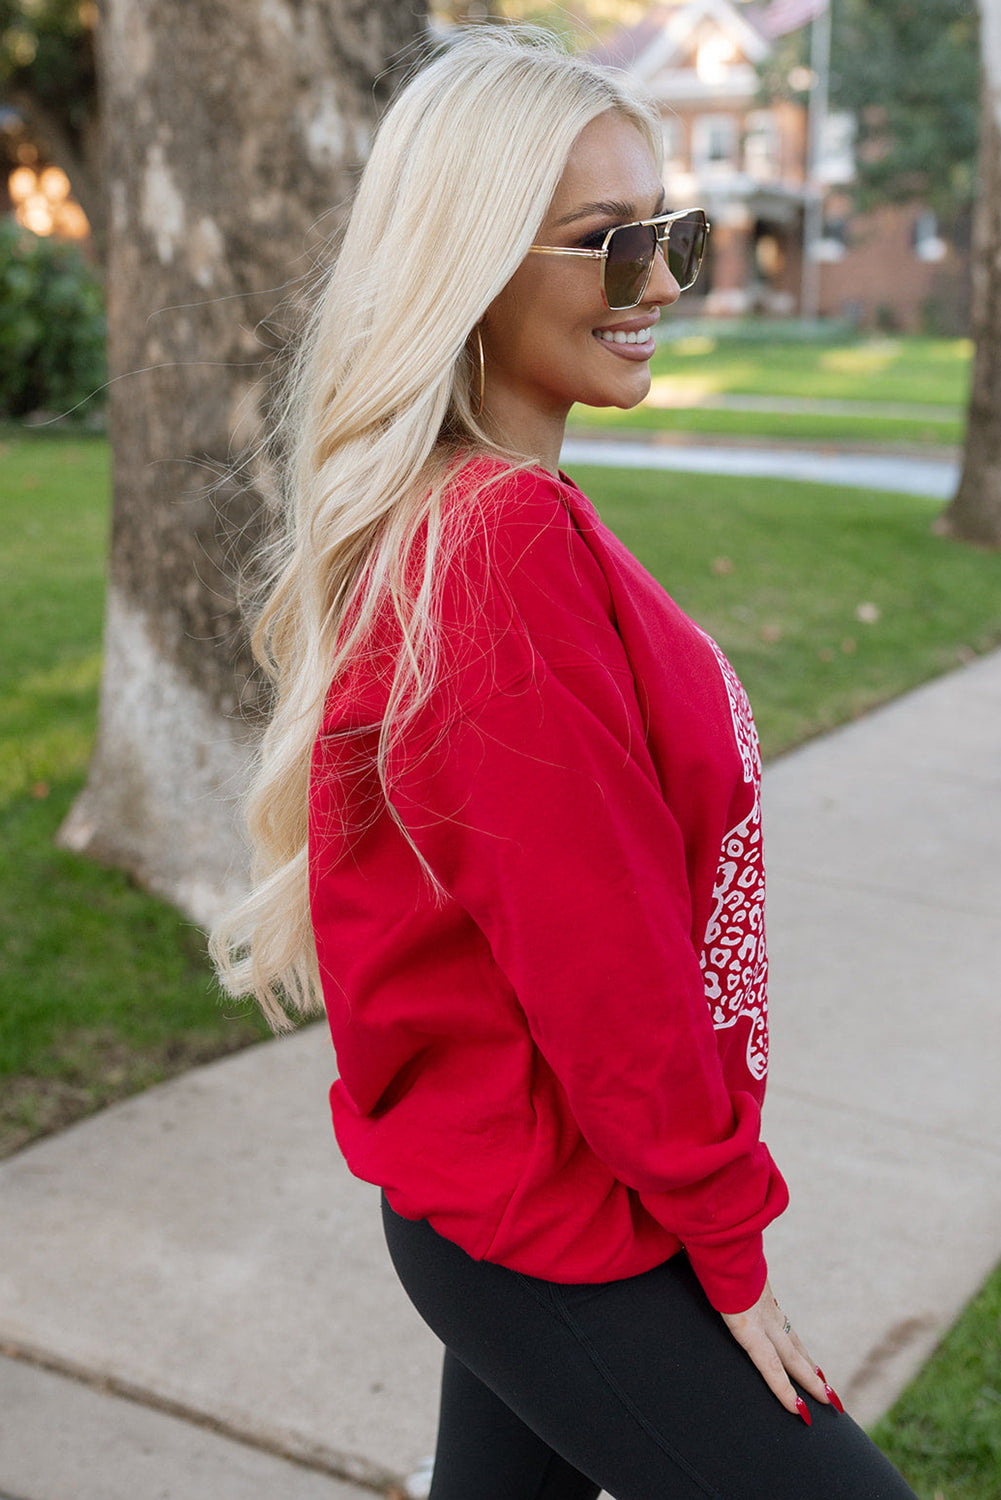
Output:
[872, 1266, 1001, 1500]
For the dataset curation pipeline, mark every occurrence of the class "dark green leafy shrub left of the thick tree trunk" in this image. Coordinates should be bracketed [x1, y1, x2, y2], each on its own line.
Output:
[0, 219, 107, 417]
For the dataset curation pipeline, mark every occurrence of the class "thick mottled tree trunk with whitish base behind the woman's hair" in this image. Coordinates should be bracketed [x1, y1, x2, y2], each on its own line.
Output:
[60, 0, 423, 923]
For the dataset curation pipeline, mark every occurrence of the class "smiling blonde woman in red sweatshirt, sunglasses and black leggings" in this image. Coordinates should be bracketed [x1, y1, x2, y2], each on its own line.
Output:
[215, 30, 911, 1500]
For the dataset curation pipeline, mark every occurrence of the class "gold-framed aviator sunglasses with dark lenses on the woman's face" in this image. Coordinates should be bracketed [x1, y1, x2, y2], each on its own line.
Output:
[530, 209, 708, 312]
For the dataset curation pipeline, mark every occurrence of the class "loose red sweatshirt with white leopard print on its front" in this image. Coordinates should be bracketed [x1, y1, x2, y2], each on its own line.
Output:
[309, 464, 788, 1313]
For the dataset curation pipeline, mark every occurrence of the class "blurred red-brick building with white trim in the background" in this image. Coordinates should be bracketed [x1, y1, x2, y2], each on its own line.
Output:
[599, 0, 969, 330]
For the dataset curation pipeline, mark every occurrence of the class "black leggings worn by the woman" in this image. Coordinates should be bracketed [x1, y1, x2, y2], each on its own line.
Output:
[383, 1200, 915, 1500]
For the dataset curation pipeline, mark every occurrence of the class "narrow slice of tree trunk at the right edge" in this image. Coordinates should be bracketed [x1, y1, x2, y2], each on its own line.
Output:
[941, 0, 1001, 548]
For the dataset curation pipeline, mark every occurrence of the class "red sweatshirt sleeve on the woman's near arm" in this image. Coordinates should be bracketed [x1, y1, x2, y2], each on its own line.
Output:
[390, 471, 786, 1313]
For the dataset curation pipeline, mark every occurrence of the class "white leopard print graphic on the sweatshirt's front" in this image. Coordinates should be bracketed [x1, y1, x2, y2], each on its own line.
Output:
[702, 636, 768, 1079]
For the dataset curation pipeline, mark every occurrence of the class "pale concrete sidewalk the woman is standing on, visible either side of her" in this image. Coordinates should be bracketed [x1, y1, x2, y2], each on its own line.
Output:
[0, 653, 1001, 1500]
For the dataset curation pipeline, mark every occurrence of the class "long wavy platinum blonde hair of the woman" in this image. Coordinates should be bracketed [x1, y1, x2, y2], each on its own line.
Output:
[210, 26, 660, 1031]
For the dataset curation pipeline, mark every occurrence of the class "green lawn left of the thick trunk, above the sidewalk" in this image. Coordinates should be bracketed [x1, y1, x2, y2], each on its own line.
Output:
[0, 435, 264, 1154]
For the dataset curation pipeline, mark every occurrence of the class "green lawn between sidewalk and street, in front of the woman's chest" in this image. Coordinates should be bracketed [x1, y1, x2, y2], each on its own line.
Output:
[573, 465, 1001, 756]
